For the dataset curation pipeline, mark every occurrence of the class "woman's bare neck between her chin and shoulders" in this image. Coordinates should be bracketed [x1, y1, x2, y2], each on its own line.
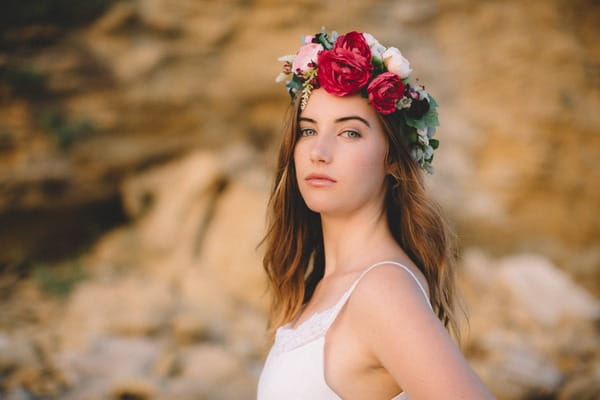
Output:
[321, 205, 402, 276]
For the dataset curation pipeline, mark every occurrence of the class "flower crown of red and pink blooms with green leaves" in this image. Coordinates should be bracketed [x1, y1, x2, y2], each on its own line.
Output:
[276, 28, 439, 174]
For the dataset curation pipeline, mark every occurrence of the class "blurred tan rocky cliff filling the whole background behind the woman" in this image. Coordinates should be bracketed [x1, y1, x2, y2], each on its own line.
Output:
[0, 0, 600, 400]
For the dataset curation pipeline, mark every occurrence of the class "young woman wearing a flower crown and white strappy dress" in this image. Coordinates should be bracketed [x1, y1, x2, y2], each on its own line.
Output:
[258, 31, 492, 400]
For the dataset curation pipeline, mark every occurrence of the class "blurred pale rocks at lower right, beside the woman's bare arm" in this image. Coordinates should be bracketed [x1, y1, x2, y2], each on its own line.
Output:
[461, 248, 600, 399]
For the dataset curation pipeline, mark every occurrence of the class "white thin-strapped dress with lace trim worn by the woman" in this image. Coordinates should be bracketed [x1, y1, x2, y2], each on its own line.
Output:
[257, 261, 431, 400]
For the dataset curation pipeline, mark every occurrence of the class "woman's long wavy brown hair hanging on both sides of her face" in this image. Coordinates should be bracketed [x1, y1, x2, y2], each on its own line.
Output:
[262, 96, 459, 337]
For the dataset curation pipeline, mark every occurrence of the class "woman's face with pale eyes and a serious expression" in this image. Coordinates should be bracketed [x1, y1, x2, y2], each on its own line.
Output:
[294, 89, 387, 216]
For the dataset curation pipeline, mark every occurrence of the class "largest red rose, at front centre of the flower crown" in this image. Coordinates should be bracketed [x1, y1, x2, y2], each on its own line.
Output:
[317, 47, 373, 96]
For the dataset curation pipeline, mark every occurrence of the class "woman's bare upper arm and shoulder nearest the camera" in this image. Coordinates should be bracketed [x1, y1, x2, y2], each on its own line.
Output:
[347, 265, 494, 400]
